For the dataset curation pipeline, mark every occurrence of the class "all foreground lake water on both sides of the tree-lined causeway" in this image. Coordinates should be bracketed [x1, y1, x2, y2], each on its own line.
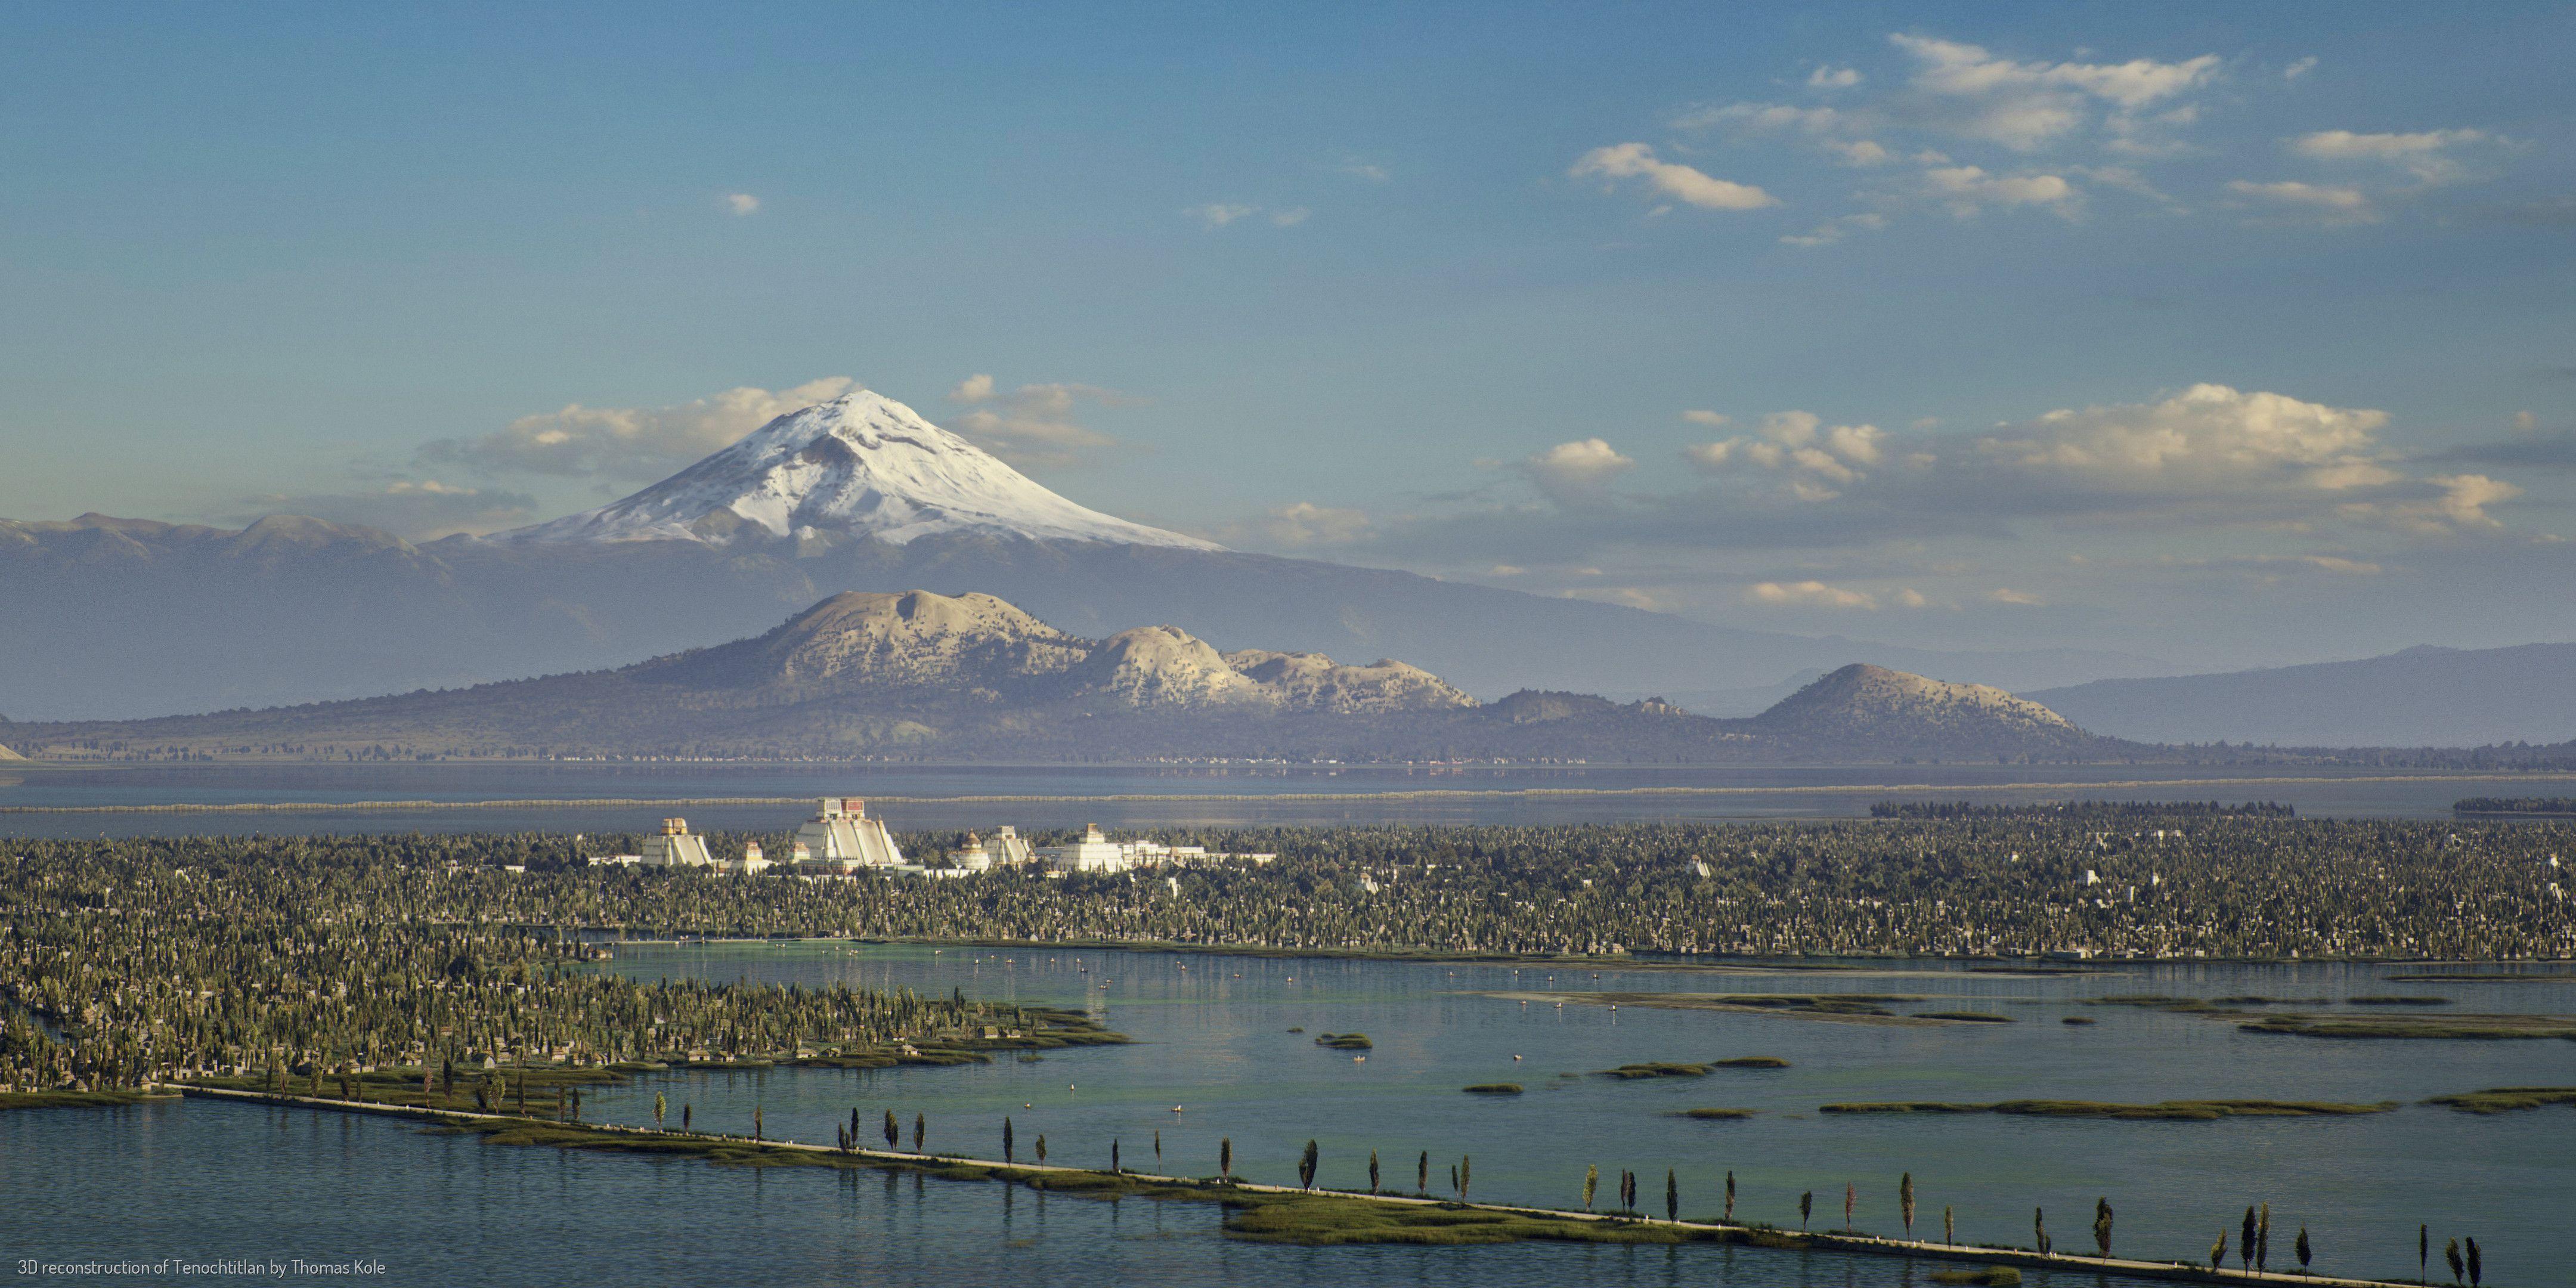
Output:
[0, 943, 2576, 1288]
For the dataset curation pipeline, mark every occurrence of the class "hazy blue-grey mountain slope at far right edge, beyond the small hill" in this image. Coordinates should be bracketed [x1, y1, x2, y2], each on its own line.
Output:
[2025, 644, 2576, 747]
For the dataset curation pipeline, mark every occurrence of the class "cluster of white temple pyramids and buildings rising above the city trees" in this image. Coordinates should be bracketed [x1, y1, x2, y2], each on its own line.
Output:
[590, 796, 1278, 876]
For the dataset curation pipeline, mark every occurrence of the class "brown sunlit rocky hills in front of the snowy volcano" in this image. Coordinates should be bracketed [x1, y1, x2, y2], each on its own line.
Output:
[5, 590, 2125, 763]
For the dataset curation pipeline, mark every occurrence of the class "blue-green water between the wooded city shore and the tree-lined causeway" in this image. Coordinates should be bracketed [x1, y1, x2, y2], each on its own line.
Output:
[618, 943, 2576, 1275]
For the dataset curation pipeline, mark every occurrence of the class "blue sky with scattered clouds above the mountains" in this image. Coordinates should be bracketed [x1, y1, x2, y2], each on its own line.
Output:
[0, 2, 2576, 665]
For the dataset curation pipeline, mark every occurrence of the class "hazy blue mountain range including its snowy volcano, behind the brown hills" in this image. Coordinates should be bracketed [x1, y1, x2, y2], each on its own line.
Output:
[0, 392, 2172, 719]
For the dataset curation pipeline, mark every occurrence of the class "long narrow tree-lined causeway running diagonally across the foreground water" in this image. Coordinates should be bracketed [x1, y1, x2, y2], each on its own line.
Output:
[170, 1082, 2408, 1288]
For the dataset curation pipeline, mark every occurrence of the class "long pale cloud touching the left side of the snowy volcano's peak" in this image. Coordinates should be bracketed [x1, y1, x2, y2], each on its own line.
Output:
[420, 376, 858, 479]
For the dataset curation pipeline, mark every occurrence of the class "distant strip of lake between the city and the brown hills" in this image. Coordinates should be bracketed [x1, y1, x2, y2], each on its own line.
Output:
[0, 763, 2576, 837]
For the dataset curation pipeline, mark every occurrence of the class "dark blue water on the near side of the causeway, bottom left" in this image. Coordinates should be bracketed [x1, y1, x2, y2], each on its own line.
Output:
[0, 1100, 1958, 1288]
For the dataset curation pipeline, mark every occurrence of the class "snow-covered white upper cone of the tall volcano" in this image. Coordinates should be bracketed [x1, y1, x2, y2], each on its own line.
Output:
[507, 389, 1224, 551]
